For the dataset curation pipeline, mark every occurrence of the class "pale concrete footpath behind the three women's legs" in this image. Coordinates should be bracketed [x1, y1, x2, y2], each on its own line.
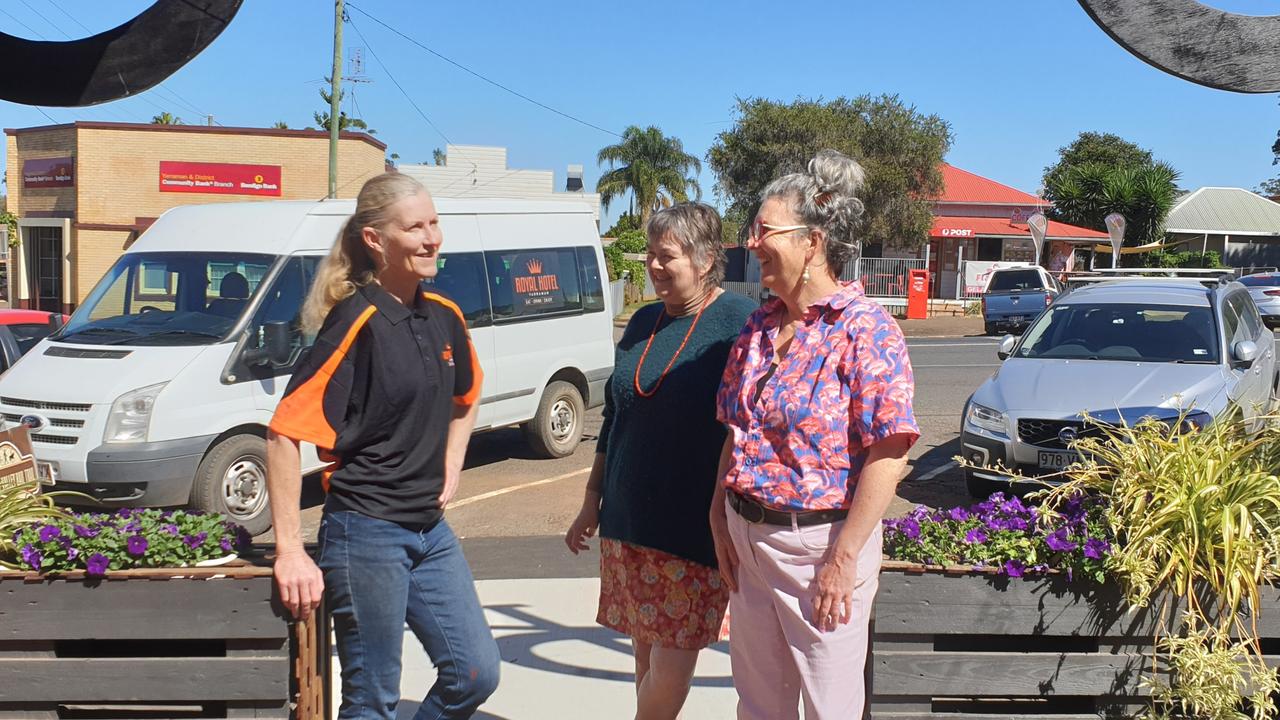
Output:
[333, 578, 737, 720]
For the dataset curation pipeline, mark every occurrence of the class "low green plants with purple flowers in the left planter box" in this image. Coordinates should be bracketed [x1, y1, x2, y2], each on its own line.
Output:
[9, 509, 250, 575]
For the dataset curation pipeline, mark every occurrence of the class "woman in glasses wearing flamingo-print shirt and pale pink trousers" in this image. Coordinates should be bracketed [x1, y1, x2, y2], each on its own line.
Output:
[710, 150, 920, 720]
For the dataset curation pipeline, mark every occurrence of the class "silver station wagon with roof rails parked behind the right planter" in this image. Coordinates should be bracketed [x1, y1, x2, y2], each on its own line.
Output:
[960, 278, 1276, 497]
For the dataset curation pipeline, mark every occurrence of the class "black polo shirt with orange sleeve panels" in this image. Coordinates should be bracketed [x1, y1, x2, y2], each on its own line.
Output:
[270, 284, 483, 527]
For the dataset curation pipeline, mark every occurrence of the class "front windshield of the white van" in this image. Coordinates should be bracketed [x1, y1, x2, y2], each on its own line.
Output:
[51, 252, 276, 346]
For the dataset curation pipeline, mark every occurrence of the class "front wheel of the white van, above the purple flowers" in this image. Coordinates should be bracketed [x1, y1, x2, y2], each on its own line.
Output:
[191, 434, 271, 536]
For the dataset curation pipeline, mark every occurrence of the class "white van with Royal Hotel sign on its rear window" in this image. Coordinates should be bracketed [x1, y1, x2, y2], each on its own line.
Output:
[0, 199, 613, 533]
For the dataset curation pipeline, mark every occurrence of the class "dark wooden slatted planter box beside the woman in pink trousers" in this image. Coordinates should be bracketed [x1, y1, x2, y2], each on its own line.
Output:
[868, 561, 1280, 720]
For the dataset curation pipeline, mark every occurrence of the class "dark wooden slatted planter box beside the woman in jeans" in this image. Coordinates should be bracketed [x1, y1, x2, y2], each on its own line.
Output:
[0, 561, 329, 719]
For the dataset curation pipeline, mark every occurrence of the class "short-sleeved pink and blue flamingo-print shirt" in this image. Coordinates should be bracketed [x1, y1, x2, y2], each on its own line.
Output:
[717, 282, 920, 511]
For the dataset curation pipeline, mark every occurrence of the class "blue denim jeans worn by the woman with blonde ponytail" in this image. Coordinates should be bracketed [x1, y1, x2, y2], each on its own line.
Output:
[320, 511, 500, 720]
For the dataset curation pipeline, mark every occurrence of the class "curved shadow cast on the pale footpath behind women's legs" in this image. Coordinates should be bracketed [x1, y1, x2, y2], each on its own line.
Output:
[485, 605, 733, 688]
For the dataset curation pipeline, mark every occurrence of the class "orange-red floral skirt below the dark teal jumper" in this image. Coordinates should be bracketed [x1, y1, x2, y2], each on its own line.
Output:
[595, 538, 728, 650]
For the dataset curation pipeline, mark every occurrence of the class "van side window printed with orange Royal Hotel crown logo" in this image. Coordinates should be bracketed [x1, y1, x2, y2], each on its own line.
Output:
[484, 247, 582, 322]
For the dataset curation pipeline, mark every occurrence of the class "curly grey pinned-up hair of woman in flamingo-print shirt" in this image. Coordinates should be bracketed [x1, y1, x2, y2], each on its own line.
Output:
[760, 150, 867, 278]
